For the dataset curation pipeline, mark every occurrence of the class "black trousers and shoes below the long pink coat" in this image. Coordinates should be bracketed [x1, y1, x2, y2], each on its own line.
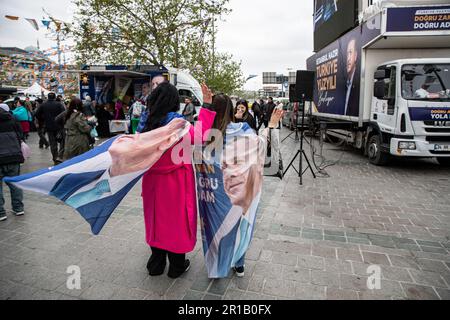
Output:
[147, 247, 186, 277]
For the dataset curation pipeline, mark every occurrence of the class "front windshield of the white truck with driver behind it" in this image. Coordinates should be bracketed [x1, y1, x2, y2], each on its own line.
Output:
[402, 64, 450, 101]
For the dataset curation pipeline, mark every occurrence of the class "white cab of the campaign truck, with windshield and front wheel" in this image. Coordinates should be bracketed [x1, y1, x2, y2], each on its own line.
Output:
[367, 59, 450, 165]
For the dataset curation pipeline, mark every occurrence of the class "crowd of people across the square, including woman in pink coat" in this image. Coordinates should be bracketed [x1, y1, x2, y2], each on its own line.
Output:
[0, 81, 282, 278]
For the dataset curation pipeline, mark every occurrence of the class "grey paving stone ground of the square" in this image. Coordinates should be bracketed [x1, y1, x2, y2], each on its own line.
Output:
[0, 130, 450, 300]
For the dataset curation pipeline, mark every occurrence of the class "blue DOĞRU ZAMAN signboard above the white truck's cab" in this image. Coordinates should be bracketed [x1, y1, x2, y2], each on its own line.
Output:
[386, 6, 450, 32]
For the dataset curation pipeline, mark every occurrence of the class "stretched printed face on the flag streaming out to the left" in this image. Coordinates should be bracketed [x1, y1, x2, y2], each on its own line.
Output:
[109, 119, 189, 176]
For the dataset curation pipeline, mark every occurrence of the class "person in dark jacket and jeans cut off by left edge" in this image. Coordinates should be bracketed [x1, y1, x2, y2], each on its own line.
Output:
[0, 104, 24, 221]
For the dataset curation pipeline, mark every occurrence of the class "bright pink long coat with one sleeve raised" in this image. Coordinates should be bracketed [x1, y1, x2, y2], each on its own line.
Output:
[142, 109, 215, 254]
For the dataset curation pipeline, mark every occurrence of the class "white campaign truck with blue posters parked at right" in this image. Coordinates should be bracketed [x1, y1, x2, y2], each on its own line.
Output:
[307, 0, 450, 165]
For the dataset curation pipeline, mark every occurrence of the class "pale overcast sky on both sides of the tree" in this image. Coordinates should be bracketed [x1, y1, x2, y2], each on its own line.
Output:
[0, 0, 313, 90]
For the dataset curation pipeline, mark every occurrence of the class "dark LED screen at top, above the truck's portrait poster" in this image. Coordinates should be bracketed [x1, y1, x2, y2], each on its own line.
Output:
[314, 0, 358, 52]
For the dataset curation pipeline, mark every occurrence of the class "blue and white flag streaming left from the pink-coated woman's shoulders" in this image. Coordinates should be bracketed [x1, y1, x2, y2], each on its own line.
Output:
[4, 119, 189, 235]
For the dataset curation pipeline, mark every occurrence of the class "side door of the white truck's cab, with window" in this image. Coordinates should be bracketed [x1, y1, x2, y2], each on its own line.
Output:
[372, 66, 398, 134]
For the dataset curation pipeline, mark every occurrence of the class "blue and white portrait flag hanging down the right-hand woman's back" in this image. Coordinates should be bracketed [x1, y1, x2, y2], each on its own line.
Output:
[195, 123, 266, 278]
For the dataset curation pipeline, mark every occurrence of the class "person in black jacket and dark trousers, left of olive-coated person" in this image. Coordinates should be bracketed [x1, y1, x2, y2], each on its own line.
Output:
[36, 92, 65, 165]
